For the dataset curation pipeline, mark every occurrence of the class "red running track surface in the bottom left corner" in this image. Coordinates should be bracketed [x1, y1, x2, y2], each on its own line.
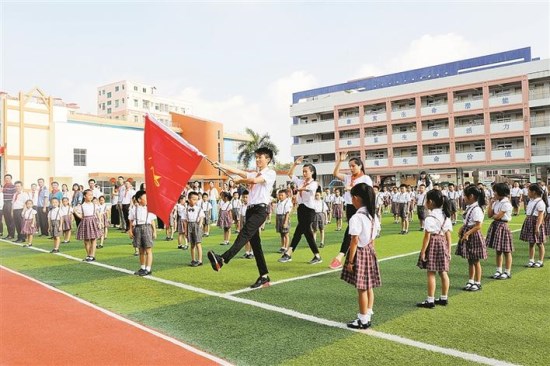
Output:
[0, 268, 227, 366]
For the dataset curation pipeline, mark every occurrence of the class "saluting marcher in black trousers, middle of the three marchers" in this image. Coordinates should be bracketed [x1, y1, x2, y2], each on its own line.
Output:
[279, 156, 323, 264]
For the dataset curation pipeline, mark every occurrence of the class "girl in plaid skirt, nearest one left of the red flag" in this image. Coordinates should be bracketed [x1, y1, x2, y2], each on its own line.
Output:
[75, 189, 103, 262]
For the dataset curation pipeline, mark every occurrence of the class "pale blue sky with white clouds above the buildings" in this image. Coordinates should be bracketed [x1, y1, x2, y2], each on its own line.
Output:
[0, 0, 550, 162]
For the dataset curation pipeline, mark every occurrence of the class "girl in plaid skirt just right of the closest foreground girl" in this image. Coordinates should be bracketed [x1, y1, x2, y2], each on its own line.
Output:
[416, 190, 453, 309]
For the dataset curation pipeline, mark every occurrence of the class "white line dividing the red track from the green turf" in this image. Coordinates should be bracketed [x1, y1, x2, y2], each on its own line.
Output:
[0, 265, 232, 366]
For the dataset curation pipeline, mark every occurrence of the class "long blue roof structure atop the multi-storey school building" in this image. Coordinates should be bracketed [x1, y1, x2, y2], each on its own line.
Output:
[292, 47, 532, 103]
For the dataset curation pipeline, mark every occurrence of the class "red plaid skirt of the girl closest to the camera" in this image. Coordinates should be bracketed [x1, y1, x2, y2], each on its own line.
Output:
[340, 244, 382, 290]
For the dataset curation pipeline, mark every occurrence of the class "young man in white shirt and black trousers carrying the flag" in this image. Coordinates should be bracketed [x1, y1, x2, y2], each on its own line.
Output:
[208, 147, 276, 288]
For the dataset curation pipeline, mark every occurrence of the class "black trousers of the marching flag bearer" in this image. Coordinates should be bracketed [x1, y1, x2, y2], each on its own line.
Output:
[222, 206, 269, 276]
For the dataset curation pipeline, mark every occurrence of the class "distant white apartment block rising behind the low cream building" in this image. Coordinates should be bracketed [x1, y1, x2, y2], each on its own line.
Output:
[97, 80, 191, 125]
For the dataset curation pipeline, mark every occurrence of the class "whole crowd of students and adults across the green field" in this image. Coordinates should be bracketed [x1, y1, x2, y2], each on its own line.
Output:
[0, 154, 550, 329]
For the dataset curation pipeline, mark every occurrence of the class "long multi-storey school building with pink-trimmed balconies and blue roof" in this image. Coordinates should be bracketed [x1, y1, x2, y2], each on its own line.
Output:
[290, 48, 550, 184]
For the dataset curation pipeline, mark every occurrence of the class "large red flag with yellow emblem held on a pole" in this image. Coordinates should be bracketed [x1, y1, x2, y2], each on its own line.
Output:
[143, 115, 204, 222]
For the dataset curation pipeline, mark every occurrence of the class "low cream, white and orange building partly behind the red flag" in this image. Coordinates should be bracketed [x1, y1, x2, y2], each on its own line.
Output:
[0, 88, 248, 193]
